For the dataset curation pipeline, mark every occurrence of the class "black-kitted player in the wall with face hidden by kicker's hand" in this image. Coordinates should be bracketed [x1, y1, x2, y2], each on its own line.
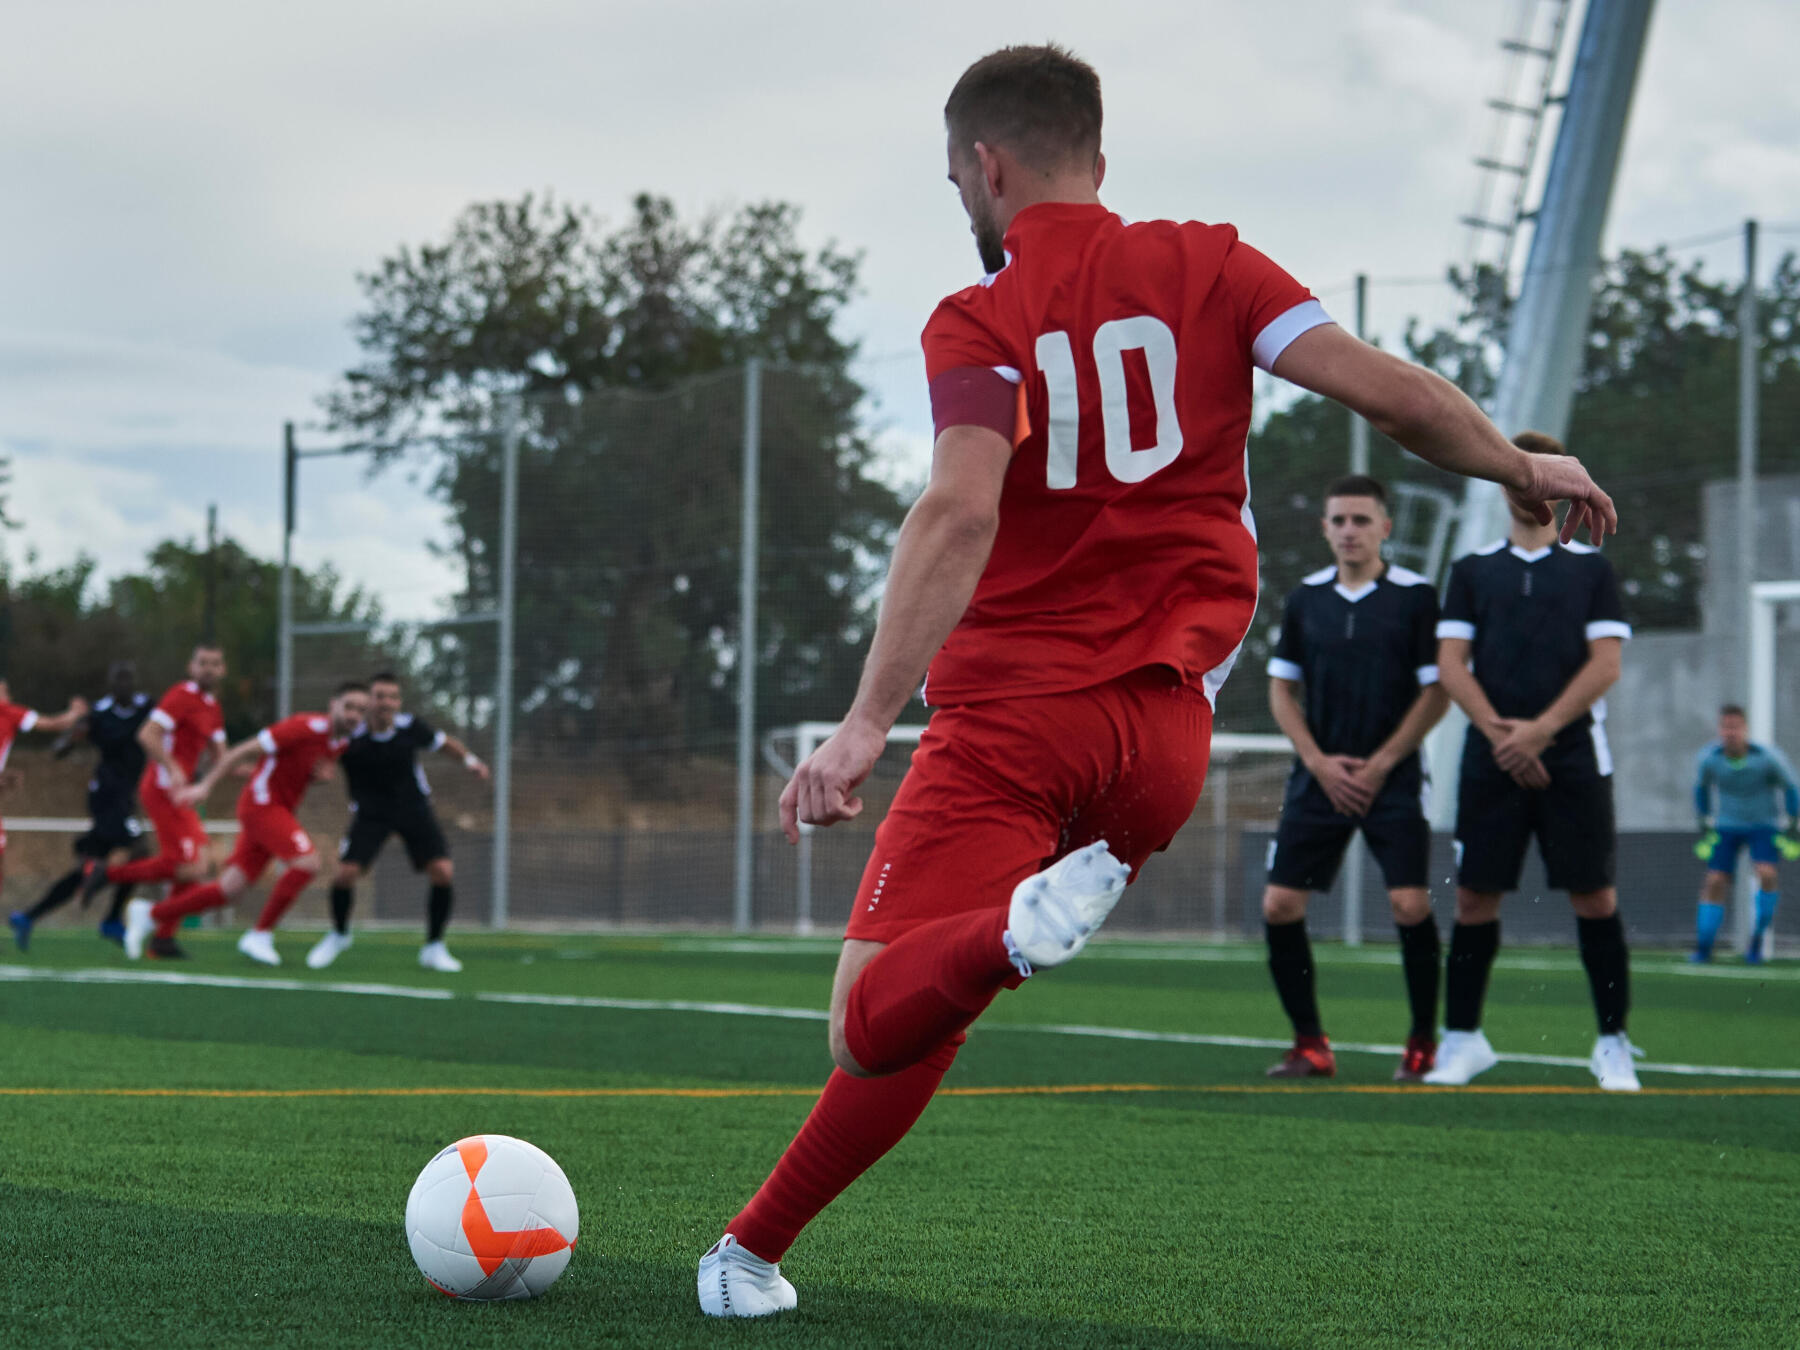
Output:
[1426, 432, 1638, 1093]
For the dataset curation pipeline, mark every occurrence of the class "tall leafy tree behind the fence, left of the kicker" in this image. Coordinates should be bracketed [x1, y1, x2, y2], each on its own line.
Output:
[326, 196, 904, 790]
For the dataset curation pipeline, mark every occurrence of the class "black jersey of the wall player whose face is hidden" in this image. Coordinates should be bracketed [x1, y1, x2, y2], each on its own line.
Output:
[1438, 540, 1631, 774]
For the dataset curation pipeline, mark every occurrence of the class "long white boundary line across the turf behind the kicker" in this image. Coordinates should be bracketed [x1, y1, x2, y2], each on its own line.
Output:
[0, 965, 1800, 1080]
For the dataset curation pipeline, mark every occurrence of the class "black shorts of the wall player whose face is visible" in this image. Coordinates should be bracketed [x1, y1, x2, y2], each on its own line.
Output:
[1269, 776, 1431, 891]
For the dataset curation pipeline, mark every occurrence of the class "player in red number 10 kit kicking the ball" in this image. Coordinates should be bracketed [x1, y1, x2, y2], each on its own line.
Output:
[698, 47, 1616, 1316]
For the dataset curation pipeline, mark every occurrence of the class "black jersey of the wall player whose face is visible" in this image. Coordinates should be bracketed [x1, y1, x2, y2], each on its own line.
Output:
[1269, 567, 1438, 785]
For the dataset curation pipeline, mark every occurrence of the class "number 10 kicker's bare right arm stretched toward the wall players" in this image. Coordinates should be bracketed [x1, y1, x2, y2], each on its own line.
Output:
[1274, 324, 1618, 544]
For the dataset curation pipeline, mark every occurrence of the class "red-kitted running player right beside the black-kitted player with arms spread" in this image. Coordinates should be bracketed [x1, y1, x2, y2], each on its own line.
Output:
[124, 680, 369, 965]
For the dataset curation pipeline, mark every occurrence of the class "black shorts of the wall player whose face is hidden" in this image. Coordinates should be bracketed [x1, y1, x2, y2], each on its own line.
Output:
[1456, 765, 1618, 895]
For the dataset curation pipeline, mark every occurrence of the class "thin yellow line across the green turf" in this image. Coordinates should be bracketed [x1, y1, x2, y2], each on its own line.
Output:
[0, 1084, 1800, 1100]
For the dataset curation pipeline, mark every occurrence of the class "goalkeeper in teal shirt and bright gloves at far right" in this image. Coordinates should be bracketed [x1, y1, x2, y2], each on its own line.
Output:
[1690, 704, 1800, 965]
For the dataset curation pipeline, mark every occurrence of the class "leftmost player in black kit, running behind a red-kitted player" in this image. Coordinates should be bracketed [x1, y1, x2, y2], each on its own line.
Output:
[11, 661, 151, 949]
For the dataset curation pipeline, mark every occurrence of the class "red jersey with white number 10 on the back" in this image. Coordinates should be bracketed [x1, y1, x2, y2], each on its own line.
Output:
[923, 203, 1330, 704]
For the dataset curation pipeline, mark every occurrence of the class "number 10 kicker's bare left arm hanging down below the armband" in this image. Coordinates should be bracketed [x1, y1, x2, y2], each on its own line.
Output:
[781, 427, 1012, 842]
